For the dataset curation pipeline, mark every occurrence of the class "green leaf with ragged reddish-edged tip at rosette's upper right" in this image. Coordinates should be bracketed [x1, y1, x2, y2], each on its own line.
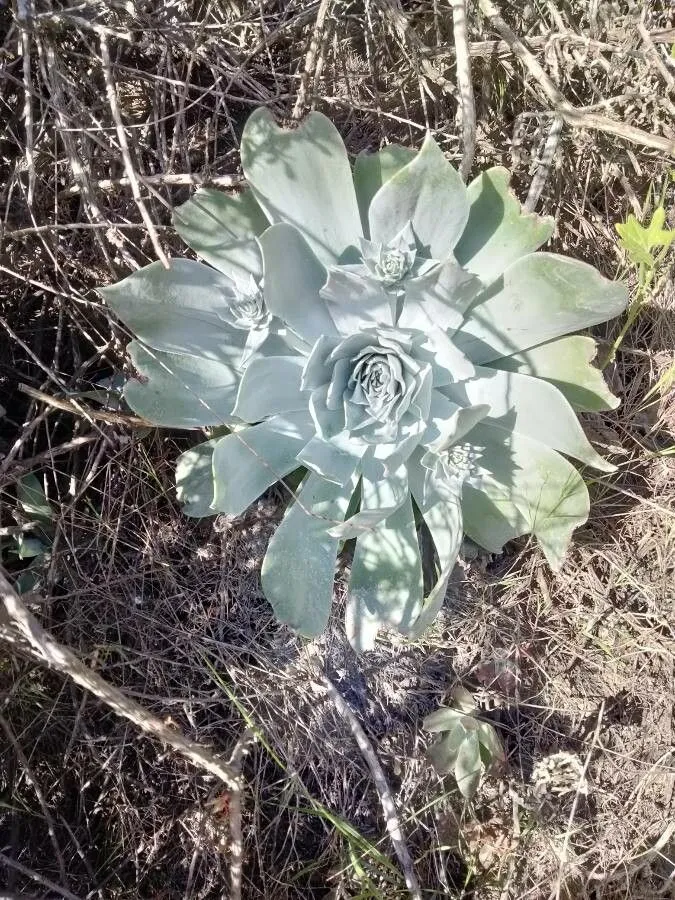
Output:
[455, 167, 553, 284]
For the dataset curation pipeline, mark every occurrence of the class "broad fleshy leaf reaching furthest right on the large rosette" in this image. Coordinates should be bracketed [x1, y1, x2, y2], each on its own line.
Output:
[453, 253, 628, 363]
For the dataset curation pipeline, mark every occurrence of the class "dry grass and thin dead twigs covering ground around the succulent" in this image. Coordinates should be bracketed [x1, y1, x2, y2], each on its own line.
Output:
[0, 0, 675, 900]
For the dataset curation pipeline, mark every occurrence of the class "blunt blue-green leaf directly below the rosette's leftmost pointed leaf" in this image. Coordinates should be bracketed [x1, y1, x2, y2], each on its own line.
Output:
[124, 341, 240, 428]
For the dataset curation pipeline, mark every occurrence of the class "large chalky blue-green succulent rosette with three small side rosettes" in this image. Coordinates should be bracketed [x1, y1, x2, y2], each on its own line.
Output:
[102, 109, 627, 649]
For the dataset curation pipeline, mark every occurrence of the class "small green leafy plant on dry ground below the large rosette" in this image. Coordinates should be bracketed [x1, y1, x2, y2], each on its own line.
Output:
[422, 688, 504, 799]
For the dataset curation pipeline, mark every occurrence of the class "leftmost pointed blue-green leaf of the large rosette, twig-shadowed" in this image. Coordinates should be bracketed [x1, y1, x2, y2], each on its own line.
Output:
[99, 259, 247, 365]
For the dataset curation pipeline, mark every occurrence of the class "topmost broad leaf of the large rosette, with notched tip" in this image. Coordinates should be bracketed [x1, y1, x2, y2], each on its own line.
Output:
[241, 108, 363, 265]
